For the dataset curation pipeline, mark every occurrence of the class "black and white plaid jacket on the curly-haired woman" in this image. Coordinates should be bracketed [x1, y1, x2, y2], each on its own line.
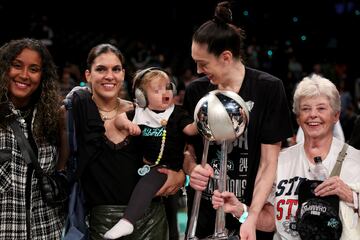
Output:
[0, 106, 64, 240]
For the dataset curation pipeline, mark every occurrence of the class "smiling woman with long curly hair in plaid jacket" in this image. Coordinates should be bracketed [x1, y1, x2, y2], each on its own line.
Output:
[0, 38, 64, 240]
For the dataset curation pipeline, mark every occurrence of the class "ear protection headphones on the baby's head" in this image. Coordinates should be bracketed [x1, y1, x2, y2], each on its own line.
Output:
[134, 67, 177, 108]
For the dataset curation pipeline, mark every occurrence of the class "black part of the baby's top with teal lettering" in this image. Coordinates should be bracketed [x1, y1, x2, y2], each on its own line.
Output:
[139, 106, 193, 171]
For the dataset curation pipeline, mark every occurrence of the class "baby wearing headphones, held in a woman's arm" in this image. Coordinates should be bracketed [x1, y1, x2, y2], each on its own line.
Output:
[104, 68, 197, 239]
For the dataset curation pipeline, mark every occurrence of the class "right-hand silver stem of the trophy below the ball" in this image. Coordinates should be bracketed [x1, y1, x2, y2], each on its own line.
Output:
[211, 140, 228, 239]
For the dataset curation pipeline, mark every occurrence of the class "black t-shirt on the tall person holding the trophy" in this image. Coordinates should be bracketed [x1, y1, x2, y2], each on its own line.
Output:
[184, 68, 292, 237]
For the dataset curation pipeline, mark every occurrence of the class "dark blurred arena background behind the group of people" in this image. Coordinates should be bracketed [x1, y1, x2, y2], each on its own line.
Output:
[0, 0, 360, 140]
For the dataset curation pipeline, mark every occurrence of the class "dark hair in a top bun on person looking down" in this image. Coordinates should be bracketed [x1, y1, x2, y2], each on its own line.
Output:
[192, 1, 245, 61]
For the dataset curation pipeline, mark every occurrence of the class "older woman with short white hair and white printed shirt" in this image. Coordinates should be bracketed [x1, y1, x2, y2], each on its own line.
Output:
[212, 75, 360, 240]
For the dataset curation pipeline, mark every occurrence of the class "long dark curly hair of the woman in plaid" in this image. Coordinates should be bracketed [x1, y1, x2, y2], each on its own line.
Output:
[0, 38, 60, 143]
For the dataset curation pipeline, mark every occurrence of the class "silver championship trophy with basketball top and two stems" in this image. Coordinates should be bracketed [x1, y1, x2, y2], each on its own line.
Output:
[186, 90, 249, 240]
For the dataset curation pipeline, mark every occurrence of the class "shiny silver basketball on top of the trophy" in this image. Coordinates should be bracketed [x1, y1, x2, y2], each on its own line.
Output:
[194, 90, 249, 141]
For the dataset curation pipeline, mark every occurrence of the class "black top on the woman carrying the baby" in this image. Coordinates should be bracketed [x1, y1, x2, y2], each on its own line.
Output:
[73, 91, 142, 207]
